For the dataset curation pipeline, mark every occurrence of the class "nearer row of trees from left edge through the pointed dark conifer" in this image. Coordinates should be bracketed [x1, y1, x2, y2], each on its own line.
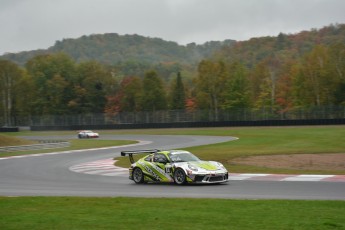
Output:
[0, 53, 191, 124]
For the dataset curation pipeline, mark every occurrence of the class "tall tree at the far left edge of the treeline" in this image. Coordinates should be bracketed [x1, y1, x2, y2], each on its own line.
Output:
[0, 60, 23, 126]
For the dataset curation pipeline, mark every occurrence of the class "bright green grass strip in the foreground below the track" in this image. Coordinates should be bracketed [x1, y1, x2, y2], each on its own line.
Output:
[0, 197, 345, 230]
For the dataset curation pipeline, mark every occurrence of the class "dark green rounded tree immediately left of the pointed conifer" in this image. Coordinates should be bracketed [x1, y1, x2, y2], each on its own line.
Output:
[142, 71, 167, 111]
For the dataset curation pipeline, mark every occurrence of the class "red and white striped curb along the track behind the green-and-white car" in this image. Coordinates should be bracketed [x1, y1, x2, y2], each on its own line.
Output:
[69, 159, 345, 182]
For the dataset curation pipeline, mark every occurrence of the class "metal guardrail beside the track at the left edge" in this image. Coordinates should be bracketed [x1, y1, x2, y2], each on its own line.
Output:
[0, 140, 70, 153]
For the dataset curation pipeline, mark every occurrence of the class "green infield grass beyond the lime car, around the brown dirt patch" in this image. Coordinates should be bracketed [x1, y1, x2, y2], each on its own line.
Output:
[113, 126, 345, 174]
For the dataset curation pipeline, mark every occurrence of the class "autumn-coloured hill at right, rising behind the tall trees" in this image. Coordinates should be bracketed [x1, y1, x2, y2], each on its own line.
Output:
[214, 24, 345, 67]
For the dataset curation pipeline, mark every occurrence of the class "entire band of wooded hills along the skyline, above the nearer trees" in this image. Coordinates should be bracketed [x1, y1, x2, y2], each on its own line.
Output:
[0, 24, 345, 68]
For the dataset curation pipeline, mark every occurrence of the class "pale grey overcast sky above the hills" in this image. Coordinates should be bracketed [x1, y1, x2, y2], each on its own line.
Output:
[0, 0, 345, 55]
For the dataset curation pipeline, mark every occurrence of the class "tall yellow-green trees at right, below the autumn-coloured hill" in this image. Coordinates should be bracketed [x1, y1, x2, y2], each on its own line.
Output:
[196, 43, 345, 119]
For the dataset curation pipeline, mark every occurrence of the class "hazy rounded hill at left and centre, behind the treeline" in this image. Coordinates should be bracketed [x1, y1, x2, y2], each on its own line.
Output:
[0, 33, 235, 65]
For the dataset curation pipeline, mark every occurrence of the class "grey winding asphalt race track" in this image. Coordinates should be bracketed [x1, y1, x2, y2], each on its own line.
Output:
[0, 135, 345, 200]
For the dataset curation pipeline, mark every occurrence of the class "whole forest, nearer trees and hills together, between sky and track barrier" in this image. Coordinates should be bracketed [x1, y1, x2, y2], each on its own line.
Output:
[0, 24, 345, 126]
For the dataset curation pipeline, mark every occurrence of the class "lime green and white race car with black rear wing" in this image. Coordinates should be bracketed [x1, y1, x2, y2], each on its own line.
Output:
[121, 149, 229, 185]
